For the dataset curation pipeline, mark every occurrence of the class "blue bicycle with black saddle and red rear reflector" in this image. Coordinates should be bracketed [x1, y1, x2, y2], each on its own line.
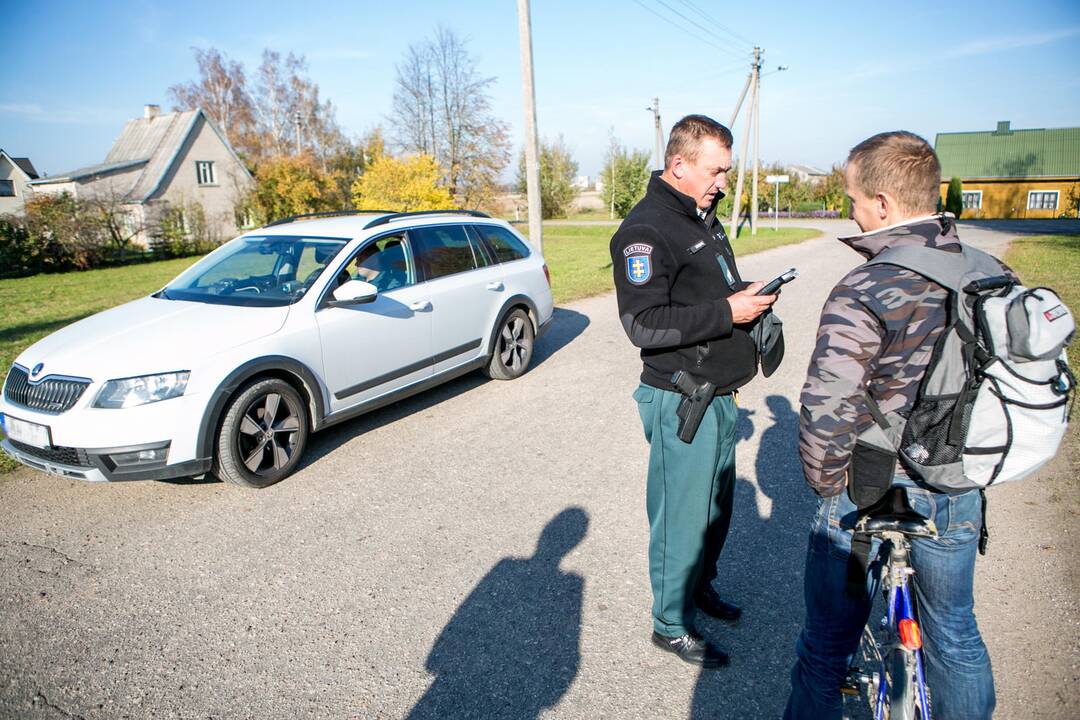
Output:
[841, 505, 937, 720]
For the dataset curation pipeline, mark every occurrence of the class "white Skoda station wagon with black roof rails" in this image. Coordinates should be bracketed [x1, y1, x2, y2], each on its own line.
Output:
[0, 210, 552, 487]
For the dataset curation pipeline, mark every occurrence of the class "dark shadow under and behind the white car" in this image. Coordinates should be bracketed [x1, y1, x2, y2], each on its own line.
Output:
[297, 308, 590, 472]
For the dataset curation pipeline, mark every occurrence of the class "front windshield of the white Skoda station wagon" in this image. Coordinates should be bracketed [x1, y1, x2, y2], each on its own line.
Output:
[157, 235, 349, 308]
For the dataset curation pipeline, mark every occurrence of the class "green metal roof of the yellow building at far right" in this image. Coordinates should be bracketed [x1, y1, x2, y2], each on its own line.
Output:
[934, 122, 1080, 180]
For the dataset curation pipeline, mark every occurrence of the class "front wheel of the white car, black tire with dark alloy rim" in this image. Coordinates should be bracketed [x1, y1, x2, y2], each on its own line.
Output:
[214, 378, 308, 488]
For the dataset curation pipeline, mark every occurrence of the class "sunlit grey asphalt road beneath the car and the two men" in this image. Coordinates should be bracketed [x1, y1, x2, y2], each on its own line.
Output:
[0, 222, 1080, 720]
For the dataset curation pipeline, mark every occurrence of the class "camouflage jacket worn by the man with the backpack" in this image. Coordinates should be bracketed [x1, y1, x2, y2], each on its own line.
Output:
[799, 211, 976, 497]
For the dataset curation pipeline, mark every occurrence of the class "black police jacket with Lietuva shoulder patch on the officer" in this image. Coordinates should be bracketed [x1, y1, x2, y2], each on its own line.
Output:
[611, 172, 757, 394]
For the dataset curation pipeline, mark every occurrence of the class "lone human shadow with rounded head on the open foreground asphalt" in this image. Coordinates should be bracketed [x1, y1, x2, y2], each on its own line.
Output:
[407, 507, 589, 720]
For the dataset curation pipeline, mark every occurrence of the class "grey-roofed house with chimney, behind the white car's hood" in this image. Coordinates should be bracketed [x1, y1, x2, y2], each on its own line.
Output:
[29, 105, 254, 244]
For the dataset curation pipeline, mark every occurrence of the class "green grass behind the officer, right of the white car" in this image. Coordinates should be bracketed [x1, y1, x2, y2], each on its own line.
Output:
[516, 225, 821, 303]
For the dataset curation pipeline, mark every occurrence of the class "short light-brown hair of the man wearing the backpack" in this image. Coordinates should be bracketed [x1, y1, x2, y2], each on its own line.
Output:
[848, 130, 942, 213]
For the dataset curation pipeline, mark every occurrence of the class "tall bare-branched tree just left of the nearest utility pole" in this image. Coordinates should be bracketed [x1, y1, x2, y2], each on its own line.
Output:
[390, 27, 510, 207]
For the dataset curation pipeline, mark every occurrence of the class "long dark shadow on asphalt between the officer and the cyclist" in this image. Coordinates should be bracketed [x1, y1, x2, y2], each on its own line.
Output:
[690, 395, 816, 718]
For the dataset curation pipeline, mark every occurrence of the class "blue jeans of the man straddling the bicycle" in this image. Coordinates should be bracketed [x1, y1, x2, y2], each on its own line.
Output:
[784, 478, 995, 720]
